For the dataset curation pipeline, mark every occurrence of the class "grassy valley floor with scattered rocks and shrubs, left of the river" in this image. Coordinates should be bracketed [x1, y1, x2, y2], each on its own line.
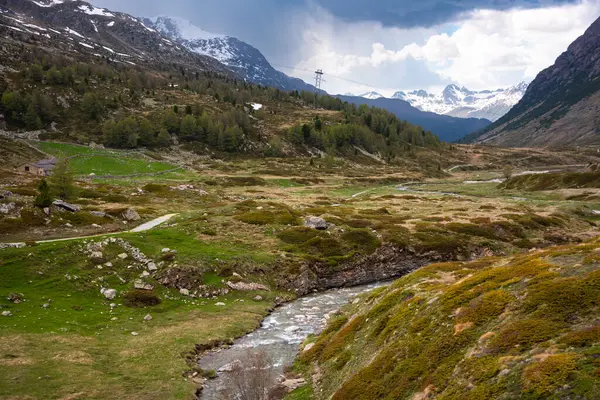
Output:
[0, 145, 600, 399]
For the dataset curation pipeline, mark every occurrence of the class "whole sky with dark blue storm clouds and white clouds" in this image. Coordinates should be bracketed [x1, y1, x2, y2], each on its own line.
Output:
[91, 0, 600, 96]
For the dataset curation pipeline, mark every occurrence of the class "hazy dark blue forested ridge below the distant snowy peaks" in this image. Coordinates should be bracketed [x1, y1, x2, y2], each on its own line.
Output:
[337, 96, 490, 142]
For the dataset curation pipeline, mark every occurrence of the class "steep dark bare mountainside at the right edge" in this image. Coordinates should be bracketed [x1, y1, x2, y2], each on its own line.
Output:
[467, 19, 600, 146]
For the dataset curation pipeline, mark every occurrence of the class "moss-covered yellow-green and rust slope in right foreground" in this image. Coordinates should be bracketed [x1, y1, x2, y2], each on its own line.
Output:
[299, 240, 600, 400]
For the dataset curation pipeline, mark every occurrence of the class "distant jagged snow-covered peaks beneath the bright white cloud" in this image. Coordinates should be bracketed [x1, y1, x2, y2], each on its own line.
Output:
[392, 82, 528, 121]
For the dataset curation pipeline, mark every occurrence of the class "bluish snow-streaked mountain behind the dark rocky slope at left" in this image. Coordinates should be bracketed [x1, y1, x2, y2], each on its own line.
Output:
[144, 16, 314, 91]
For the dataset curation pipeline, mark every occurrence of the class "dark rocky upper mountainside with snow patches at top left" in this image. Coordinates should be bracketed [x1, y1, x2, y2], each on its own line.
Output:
[0, 0, 231, 75]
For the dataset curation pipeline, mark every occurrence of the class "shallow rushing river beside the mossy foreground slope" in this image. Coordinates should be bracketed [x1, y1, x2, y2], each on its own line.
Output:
[199, 283, 386, 400]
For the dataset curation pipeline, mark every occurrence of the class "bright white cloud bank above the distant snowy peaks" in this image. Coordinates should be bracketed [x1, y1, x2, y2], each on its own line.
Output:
[297, 0, 600, 94]
